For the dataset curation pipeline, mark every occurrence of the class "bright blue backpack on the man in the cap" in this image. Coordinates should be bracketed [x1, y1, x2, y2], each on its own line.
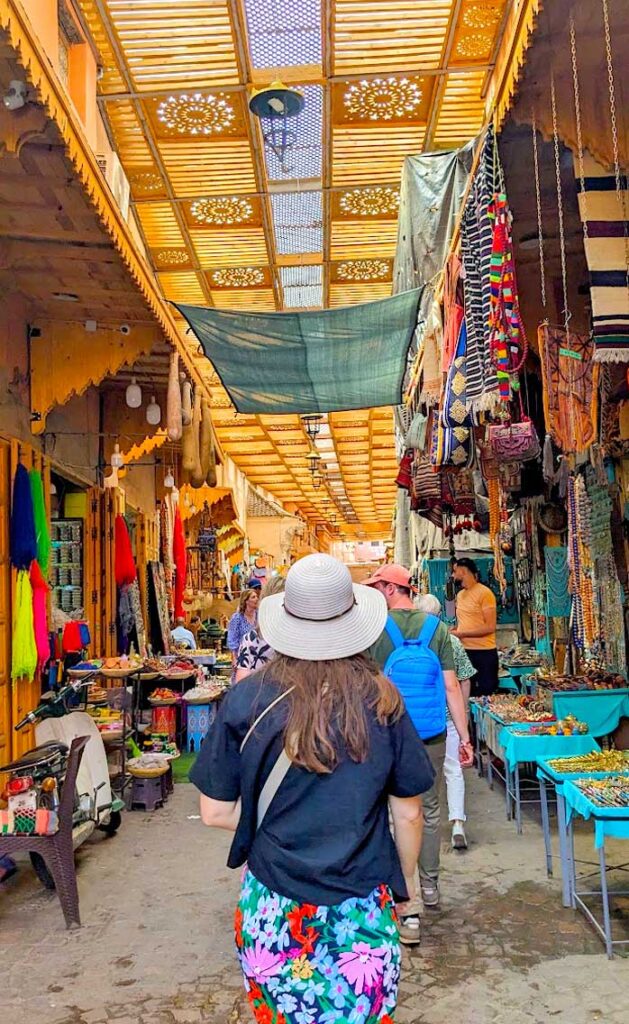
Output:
[383, 615, 446, 739]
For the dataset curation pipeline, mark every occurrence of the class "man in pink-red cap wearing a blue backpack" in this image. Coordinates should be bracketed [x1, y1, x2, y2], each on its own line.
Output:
[364, 565, 473, 944]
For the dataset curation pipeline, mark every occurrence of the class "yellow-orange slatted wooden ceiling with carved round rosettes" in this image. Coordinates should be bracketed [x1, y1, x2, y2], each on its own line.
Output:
[79, 0, 506, 531]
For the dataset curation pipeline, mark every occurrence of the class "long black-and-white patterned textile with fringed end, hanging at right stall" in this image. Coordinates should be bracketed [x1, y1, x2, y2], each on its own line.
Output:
[461, 128, 498, 412]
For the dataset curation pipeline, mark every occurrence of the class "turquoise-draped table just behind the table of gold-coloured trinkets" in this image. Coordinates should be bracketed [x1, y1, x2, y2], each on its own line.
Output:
[498, 723, 600, 835]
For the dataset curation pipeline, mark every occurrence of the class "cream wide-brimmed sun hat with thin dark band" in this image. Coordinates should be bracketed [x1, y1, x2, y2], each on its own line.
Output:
[258, 555, 387, 662]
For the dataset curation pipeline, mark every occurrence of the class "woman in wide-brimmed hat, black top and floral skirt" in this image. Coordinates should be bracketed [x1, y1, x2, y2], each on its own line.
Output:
[191, 555, 433, 1024]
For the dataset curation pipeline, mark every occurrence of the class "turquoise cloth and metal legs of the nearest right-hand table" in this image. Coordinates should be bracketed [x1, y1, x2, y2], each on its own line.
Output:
[563, 780, 629, 959]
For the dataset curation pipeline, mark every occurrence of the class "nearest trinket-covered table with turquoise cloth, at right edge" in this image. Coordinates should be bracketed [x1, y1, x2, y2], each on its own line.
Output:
[563, 773, 629, 959]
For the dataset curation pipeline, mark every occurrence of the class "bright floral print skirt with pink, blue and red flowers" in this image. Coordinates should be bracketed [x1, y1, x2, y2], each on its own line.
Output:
[236, 870, 402, 1024]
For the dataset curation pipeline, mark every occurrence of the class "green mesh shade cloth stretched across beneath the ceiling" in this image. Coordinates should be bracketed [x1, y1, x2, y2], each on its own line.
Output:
[176, 289, 421, 413]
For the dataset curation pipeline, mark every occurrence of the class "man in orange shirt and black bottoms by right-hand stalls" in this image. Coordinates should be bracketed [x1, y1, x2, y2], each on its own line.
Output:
[451, 558, 499, 697]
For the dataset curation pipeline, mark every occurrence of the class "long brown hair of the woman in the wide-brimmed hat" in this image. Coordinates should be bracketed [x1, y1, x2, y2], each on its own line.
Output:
[261, 654, 404, 773]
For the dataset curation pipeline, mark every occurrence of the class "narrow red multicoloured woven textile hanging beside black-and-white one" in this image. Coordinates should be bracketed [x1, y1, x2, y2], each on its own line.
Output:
[489, 193, 528, 401]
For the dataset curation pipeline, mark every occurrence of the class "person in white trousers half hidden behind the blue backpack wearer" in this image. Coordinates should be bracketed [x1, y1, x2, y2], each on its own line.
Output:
[417, 594, 476, 851]
